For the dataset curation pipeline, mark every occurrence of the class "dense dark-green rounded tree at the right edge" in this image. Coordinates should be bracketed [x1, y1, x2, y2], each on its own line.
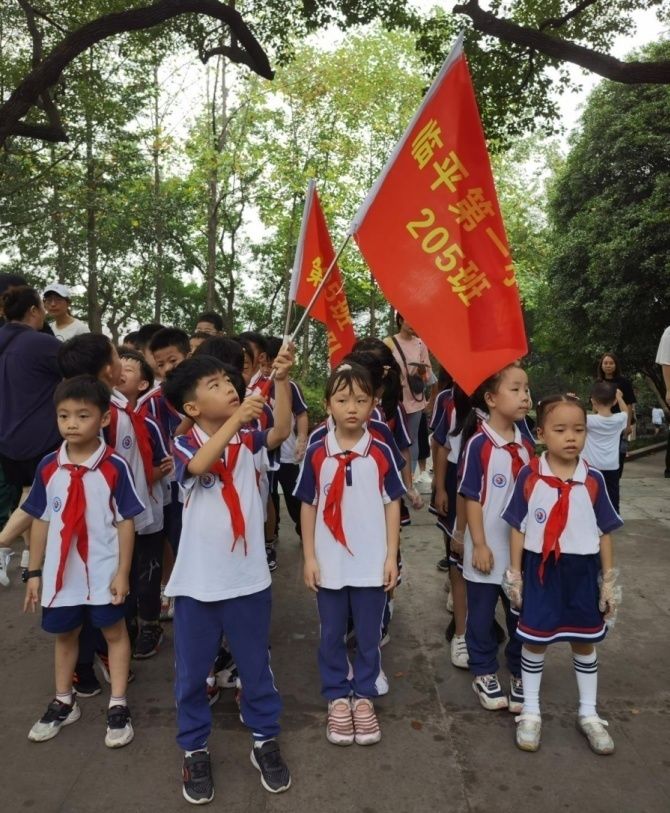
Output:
[545, 42, 670, 391]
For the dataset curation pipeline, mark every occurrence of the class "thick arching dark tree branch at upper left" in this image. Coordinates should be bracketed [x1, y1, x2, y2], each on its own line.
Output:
[0, 0, 274, 146]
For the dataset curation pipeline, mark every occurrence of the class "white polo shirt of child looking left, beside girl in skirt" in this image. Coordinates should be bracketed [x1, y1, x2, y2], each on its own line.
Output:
[458, 421, 534, 584]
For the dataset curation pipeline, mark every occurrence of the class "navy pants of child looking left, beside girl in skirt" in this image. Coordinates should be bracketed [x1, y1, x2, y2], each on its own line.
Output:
[465, 581, 521, 677]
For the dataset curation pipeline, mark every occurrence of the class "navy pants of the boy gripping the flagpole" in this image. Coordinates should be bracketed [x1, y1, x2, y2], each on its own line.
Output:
[174, 587, 282, 751]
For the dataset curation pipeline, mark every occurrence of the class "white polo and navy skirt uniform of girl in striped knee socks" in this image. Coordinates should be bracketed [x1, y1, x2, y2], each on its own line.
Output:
[503, 453, 623, 644]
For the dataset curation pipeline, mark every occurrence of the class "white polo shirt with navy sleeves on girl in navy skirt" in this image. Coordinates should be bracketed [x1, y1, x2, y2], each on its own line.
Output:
[503, 452, 623, 556]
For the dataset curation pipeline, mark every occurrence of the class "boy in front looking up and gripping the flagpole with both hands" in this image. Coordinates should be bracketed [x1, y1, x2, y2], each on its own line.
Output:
[163, 349, 292, 804]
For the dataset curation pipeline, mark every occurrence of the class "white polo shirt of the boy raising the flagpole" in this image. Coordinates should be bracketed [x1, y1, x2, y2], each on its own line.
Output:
[165, 424, 271, 601]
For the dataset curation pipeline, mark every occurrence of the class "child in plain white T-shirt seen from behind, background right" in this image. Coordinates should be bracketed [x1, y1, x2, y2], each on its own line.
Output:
[583, 381, 630, 514]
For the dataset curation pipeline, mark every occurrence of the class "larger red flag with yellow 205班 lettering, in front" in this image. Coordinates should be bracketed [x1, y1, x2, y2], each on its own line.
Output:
[350, 37, 528, 393]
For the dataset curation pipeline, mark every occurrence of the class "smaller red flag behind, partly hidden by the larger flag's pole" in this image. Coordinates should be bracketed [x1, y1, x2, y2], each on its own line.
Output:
[289, 181, 356, 367]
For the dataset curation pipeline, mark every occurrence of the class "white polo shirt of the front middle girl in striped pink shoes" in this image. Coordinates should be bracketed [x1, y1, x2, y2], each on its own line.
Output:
[293, 430, 405, 590]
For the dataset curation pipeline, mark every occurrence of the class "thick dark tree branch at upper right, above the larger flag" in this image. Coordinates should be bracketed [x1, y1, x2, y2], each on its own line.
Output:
[453, 0, 670, 85]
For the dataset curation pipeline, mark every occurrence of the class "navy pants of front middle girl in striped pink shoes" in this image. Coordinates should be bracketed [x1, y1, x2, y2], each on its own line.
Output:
[317, 587, 386, 700]
